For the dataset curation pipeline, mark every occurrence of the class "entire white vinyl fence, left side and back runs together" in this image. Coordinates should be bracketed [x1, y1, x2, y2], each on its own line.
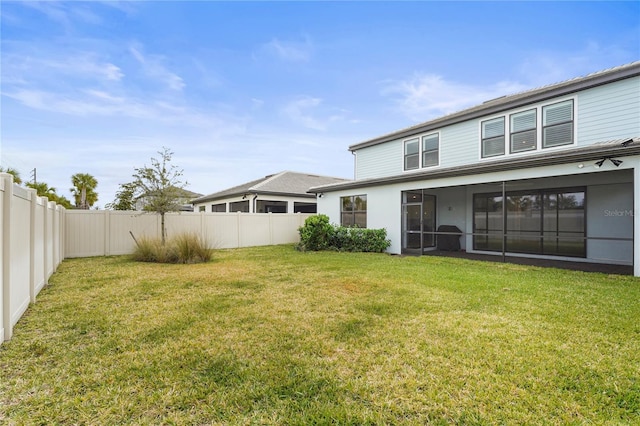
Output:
[0, 173, 311, 344]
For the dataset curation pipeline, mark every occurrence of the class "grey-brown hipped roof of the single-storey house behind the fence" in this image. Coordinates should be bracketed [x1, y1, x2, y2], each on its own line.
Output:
[193, 171, 348, 203]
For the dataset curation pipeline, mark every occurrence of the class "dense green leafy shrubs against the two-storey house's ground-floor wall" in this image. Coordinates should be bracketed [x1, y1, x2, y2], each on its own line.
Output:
[298, 215, 391, 253]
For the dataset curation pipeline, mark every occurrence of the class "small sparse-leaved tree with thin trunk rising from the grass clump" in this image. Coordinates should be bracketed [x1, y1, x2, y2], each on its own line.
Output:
[132, 147, 188, 244]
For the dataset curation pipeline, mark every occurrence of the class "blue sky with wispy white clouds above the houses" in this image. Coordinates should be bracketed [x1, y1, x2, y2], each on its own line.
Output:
[0, 1, 640, 207]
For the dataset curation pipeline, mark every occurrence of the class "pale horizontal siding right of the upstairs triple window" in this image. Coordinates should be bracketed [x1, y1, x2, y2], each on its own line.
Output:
[576, 77, 640, 145]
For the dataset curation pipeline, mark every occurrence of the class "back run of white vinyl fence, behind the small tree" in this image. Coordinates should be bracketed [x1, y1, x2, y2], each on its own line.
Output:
[64, 210, 311, 258]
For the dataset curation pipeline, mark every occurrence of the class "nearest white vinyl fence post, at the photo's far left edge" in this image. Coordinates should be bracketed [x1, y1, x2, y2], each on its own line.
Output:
[0, 173, 13, 340]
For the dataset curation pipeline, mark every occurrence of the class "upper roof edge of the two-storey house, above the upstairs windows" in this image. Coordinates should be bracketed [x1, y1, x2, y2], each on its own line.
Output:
[349, 61, 640, 151]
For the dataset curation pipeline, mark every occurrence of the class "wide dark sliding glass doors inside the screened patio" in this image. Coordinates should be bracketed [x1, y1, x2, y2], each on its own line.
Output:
[473, 188, 586, 257]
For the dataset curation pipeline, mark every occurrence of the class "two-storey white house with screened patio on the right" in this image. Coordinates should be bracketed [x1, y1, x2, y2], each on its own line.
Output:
[310, 62, 640, 276]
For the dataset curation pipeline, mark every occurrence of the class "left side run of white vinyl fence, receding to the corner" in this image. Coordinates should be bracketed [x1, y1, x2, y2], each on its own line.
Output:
[0, 173, 66, 343]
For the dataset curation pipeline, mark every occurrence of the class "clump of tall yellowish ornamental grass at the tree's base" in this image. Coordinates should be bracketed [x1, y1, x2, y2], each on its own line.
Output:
[132, 233, 213, 263]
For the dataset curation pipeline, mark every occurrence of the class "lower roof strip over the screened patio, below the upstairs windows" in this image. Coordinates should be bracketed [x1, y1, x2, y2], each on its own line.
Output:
[309, 136, 640, 194]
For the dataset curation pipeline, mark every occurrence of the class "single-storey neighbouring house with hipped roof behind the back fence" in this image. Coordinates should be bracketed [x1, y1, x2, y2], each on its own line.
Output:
[193, 171, 347, 213]
